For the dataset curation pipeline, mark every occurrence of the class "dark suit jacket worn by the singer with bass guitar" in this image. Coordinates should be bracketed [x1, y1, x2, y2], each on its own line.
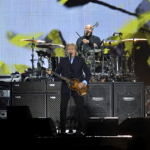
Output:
[55, 56, 91, 93]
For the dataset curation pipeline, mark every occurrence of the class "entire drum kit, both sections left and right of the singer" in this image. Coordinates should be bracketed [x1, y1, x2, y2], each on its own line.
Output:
[21, 38, 147, 82]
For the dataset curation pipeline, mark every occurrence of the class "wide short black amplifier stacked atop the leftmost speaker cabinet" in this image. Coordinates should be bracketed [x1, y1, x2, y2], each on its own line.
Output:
[12, 81, 46, 94]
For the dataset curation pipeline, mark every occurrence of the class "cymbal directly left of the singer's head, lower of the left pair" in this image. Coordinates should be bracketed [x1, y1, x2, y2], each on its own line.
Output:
[36, 43, 65, 49]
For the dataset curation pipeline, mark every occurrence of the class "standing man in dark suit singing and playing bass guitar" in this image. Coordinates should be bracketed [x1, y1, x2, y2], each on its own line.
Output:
[47, 43, 91, 134]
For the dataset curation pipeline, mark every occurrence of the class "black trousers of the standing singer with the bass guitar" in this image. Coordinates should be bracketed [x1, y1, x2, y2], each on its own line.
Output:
[60, 90, 85, 132]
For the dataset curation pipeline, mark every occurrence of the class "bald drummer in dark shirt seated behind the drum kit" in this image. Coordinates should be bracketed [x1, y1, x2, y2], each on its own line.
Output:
[76, 24, 101, 59]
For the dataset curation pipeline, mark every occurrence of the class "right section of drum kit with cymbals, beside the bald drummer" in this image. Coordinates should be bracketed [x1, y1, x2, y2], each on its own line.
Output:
[82, 38, 147, 82]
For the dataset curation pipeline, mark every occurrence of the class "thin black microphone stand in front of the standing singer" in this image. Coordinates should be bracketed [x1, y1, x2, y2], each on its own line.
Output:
[68, 53, 73, 134]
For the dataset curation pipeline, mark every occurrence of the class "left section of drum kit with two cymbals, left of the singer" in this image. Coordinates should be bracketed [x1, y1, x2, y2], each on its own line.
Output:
[21, 38, 65, 81]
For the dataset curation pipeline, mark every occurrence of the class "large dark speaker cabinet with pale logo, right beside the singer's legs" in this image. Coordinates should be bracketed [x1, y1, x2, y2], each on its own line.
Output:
[84, 82, 113, 117]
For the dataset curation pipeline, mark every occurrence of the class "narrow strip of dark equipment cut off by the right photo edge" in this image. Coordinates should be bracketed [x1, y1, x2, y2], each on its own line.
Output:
[145, 86, 150, 117]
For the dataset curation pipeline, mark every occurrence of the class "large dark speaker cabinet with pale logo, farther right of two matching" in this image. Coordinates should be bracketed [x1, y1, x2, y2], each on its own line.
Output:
[114, 82, 144, 124]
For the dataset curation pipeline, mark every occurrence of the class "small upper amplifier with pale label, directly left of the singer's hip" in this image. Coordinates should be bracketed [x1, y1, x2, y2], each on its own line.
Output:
[46, 81, 61, 94]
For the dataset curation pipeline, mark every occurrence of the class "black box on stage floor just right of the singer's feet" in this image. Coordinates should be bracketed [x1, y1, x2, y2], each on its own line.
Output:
[85, 117, 118, 136]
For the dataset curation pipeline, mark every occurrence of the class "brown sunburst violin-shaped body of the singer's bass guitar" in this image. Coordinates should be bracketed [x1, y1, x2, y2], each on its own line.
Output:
[69, 78, 89, 96]
